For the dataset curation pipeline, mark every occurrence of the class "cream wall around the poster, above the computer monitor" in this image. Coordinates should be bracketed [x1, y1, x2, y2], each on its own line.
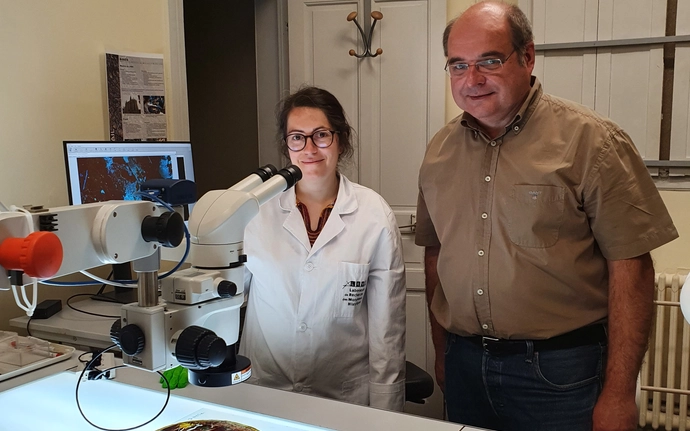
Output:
[0, 0, 174, 329]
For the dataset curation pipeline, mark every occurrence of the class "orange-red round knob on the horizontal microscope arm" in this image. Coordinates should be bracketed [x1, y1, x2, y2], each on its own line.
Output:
[0, 232, 62, 278]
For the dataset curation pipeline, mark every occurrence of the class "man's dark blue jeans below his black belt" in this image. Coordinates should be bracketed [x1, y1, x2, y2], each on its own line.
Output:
[445, 334, 606, 431]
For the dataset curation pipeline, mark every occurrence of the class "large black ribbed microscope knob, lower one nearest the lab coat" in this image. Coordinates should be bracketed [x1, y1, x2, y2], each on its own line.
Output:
[175, 326, 227, 369]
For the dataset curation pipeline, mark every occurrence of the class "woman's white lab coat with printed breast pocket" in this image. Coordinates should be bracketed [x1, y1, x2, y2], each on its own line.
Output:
[240, 175, 405, 411]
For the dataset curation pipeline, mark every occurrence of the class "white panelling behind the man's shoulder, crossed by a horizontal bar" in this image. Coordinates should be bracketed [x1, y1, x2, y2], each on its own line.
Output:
[518, 0, 664, 160]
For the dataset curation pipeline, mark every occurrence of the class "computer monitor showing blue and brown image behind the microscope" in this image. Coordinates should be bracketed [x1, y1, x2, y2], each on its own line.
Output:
[64, 141, 194, 303]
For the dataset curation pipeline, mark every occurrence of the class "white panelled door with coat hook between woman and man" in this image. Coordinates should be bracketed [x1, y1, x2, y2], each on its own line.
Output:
[288, 0, 446, 417]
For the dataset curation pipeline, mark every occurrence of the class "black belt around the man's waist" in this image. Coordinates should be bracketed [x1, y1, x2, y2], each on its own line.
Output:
[459, 324, 607, 355]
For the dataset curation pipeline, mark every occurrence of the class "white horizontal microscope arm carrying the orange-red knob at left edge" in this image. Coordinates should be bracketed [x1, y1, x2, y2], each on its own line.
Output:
[0, 201, 182, 287]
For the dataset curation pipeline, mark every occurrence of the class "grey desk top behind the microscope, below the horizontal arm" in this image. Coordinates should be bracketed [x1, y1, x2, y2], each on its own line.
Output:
[10, 299, 122, 349]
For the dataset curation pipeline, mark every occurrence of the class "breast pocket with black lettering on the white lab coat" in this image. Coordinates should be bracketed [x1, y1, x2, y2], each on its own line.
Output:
[335, 262, 369, 318]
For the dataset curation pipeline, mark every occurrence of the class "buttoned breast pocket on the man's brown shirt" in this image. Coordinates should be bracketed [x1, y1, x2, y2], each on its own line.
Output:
[508, 184, 565, 248]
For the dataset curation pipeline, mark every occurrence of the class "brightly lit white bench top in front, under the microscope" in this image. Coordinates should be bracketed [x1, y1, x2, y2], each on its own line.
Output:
[0, 360, 479, 431]
